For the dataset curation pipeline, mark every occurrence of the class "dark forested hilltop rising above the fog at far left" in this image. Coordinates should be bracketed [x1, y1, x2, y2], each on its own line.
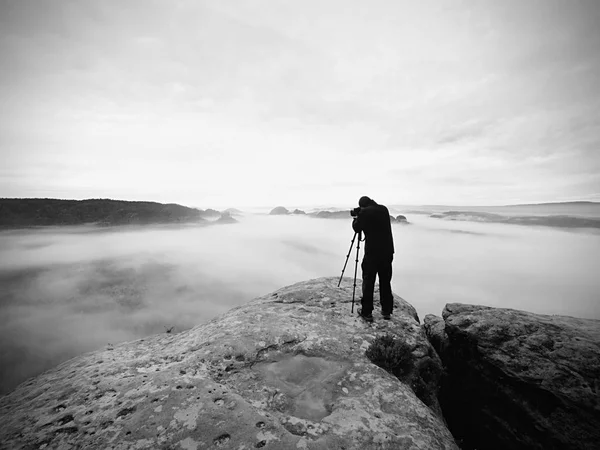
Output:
[0, 198, 204, 228]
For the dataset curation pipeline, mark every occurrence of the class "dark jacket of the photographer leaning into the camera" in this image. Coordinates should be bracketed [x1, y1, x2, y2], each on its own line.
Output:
[352, 202, 394, 258]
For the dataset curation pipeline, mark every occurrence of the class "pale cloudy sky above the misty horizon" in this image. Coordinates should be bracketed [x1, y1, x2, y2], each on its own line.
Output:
[0, 0, 600, 207]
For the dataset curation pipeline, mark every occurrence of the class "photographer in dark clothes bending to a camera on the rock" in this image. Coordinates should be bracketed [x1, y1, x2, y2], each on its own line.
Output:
[352, 196, 394, 322]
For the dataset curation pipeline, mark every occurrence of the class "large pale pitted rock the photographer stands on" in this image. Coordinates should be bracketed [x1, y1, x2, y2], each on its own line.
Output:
[0, 278, 457, 450]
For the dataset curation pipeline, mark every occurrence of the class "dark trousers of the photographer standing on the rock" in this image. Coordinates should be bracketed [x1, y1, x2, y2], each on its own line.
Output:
[360, 255, 394, 315]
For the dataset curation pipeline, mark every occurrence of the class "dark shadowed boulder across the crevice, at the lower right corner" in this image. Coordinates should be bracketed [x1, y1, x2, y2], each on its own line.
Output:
[426, 304, 600, 449]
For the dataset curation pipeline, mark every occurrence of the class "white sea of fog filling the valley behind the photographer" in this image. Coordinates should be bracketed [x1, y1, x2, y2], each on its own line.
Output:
[0, 214, 600, 393]
